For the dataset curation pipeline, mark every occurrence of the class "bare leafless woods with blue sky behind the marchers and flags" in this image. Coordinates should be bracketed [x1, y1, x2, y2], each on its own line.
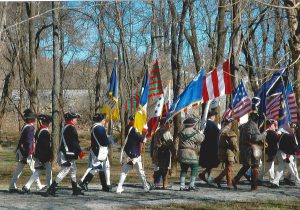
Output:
[0, 0, 300, 155]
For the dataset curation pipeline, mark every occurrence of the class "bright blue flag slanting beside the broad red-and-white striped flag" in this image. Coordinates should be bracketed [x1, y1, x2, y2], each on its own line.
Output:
[166, 68, 205, 121]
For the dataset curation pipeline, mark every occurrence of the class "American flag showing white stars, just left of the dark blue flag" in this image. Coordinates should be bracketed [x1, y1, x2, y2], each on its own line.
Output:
[232, 81, 252, 119]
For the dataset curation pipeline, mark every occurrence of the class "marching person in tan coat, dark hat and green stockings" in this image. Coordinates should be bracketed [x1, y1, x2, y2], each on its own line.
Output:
[178, 117, 204, 191]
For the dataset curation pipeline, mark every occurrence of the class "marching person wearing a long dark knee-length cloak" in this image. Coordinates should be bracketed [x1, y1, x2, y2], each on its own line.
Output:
[198, 110, 220, 184]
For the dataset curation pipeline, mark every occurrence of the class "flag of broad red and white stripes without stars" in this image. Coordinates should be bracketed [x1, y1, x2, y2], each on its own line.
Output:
[202, 60, 232, 102]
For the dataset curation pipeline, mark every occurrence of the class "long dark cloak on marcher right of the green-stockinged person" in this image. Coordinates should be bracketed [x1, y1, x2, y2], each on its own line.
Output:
[199, 120, 220, 168]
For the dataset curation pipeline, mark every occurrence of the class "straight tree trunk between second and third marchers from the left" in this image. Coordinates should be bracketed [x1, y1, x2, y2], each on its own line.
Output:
[52, 1, 60, 160]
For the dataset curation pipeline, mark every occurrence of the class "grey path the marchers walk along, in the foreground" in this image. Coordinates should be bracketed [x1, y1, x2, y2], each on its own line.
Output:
[0, 181, 300, 210]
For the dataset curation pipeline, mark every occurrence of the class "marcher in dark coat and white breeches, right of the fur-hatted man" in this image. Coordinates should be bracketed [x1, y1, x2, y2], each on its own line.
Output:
[258, 119, 279, 184]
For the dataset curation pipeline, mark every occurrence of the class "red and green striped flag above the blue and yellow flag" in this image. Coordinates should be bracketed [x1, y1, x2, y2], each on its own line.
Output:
[148, 59, 164, 98]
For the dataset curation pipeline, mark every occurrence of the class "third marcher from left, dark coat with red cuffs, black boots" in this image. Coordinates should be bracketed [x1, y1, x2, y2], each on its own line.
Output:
[46, 112, 84, 195]
